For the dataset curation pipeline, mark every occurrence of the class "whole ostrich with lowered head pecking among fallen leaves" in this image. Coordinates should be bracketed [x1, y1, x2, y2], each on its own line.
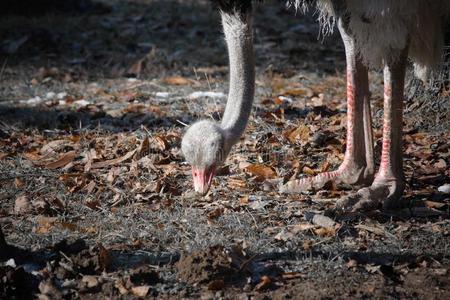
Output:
[182, 0, 450, 211]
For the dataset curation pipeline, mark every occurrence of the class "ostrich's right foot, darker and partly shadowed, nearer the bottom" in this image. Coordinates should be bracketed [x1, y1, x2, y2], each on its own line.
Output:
[336, 178, 405, 212]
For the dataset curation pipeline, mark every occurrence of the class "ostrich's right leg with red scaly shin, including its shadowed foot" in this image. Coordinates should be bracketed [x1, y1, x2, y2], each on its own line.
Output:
[337, 48, 408, 211]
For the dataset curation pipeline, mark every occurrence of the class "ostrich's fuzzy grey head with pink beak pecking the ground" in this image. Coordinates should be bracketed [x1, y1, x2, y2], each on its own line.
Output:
[181, 120, 227, 195]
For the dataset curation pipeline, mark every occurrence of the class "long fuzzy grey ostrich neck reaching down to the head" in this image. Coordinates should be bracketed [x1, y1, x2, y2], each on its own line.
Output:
[221, 12, 255, 151]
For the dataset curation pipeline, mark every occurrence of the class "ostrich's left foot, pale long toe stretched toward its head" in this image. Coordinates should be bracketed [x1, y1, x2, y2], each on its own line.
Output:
[280, 164, 373, 194]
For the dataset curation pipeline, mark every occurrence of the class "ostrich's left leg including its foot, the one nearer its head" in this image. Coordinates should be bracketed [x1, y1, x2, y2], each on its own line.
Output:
[281, 18, 374, 193]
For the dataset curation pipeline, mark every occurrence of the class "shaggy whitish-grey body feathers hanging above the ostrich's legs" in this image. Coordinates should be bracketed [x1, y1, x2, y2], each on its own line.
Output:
[288, 0, 450, 78]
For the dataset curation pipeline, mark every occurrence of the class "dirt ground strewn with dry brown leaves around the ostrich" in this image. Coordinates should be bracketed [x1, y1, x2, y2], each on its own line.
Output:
[0, 0, 450, 299]
